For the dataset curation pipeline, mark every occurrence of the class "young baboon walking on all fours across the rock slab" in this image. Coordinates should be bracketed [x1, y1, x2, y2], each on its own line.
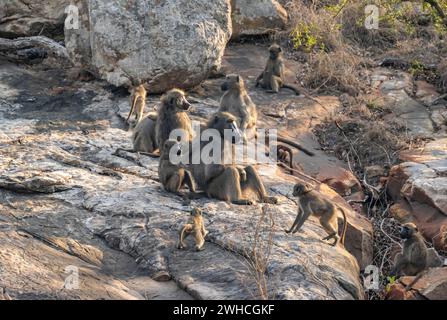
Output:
[285, 183, 348, 246]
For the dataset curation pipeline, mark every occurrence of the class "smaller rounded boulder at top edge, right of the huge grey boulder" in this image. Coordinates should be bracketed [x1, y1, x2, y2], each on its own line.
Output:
[231, 0, 288, 38]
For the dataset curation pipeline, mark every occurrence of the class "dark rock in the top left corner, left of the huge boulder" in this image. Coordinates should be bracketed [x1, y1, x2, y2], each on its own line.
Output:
[0, 0, 70, 38]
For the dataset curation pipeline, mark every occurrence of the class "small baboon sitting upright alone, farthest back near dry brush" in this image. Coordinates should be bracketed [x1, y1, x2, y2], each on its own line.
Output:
[256, 44, 300, 95]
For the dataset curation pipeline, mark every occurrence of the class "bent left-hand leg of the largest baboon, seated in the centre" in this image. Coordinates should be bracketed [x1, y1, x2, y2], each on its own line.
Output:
[207, 167, 253, 205]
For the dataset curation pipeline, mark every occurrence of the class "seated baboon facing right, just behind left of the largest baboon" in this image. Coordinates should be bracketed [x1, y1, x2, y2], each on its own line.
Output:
[155, 89, 192, 153]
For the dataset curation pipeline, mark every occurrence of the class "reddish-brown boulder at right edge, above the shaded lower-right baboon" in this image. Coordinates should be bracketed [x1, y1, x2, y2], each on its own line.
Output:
[388, 138, 447, 250]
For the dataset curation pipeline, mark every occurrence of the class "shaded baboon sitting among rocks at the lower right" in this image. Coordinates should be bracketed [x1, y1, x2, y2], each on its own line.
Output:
[391, 223, 427, 277]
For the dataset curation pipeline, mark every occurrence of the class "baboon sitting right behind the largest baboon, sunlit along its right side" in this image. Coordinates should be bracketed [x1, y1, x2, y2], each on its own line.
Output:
[219, 74, 258, 139]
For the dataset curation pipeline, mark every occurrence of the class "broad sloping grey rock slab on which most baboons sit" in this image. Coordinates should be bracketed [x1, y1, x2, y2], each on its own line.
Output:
[0, 46, 370, 299]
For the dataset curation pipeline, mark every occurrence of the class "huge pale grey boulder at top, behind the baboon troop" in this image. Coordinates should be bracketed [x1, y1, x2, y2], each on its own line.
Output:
[65, 0, 232, 93]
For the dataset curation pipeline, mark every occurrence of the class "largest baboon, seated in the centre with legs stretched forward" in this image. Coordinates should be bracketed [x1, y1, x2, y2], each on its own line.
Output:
[189, 112, 278, 205]
